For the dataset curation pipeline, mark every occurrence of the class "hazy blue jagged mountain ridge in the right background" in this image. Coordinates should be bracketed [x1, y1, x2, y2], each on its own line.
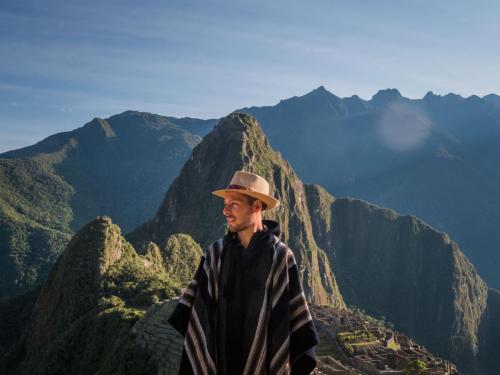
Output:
[236, 86, 500, 288]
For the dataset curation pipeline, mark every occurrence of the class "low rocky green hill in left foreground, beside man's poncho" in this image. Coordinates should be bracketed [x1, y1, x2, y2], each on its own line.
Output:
[0, 217, 201, 375]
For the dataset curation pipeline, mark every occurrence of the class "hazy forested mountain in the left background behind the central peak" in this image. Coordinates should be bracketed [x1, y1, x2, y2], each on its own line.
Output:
[0, 111, 213, 296]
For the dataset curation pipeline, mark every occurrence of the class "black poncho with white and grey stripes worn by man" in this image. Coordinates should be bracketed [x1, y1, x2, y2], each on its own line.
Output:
[169, 221, 319, 375]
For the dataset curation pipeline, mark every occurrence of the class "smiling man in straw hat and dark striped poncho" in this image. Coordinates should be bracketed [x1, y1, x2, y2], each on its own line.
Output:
[168, 171, 319, 375]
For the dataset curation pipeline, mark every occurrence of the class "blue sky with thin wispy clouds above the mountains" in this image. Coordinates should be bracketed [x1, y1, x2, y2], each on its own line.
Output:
[0, 0, 500, 152]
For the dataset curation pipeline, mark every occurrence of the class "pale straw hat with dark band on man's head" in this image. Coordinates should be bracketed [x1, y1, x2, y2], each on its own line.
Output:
[212, 171, 280, 210]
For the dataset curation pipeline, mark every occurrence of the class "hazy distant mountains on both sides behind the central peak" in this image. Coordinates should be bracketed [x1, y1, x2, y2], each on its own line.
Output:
[0, 86, 500, 295]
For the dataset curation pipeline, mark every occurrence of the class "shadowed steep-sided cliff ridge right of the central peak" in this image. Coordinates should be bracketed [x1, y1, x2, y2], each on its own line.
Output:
[307, 185, 490, 373]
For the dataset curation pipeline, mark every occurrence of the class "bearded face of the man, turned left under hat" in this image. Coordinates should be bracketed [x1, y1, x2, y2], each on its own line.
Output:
[222, 191, 260, 232]
